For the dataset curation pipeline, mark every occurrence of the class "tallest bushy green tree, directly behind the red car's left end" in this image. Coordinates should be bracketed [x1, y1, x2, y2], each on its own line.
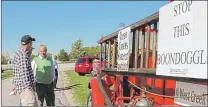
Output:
[70, 39, 86, 59]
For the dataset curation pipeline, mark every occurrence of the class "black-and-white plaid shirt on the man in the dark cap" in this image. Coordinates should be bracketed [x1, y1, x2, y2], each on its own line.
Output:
[12, 49, 35, 93]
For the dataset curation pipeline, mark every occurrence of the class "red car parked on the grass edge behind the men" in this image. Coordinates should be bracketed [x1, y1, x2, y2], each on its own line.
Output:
[74, 56, 99, 76]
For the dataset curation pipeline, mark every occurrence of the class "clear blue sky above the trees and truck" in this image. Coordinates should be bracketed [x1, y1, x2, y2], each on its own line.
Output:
[2, 1, 169, 53]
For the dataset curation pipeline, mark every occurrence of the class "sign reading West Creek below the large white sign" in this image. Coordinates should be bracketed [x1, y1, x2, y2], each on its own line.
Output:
[174, 81, 208, 107]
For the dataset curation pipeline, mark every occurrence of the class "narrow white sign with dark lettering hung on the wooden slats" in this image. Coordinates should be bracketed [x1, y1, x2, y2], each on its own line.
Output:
[117, 27, 131, 71]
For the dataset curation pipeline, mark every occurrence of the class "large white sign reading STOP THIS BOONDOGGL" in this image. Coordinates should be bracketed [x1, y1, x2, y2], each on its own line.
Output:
[156, 1, 208, 79]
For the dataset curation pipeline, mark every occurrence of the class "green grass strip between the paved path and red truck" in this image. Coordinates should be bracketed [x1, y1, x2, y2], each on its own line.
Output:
[64, 70, 91, 106]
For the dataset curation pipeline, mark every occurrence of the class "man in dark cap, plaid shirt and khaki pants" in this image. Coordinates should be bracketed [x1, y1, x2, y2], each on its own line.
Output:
[12, 35, 37, 106]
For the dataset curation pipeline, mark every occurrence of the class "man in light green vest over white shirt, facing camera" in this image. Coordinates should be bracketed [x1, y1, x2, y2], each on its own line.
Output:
[32, 45, 55, 106]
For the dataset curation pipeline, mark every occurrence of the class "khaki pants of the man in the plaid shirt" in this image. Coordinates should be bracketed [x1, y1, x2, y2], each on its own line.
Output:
[20, 88, 38, 106]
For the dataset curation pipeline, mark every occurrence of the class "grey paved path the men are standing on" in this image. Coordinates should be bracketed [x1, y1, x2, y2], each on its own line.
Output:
[1, 64, 74, 106]
